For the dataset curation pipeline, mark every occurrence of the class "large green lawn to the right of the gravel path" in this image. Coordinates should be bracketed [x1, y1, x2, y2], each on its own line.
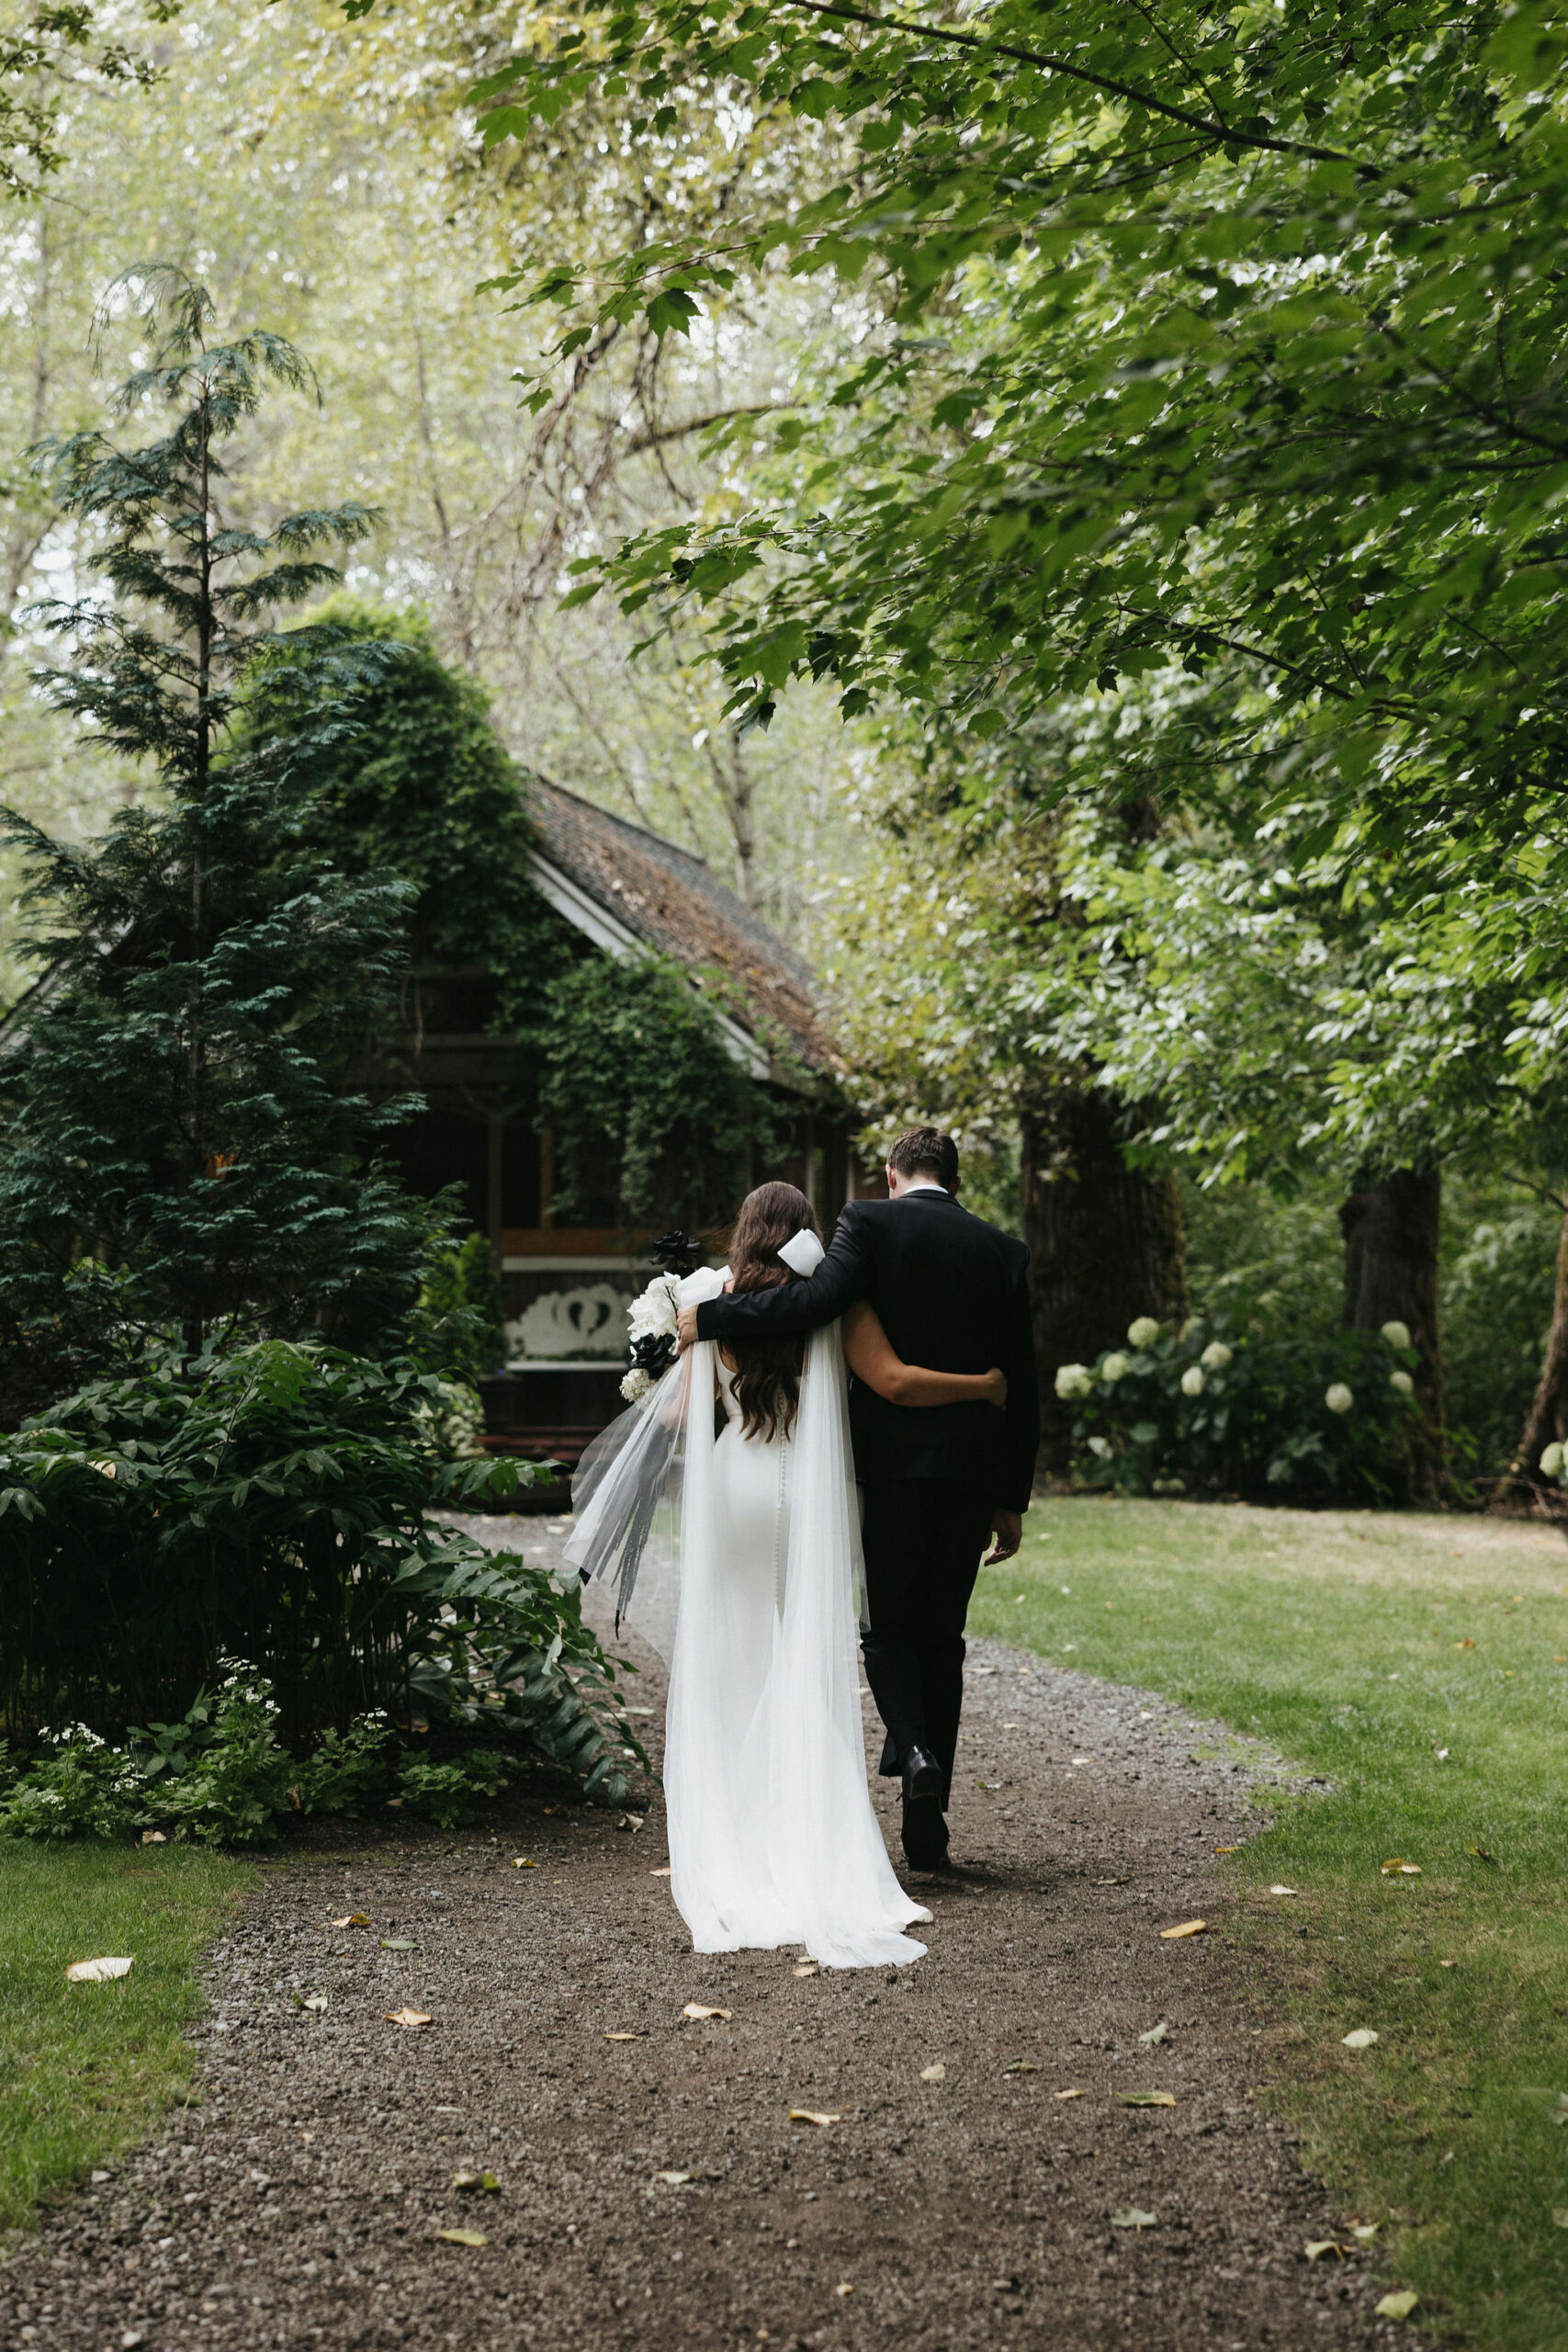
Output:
[971, 1500, 1568, 2352]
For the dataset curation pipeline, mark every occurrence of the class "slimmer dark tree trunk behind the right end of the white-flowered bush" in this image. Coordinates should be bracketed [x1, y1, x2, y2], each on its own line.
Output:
[1340, 1169, 1448, 1498]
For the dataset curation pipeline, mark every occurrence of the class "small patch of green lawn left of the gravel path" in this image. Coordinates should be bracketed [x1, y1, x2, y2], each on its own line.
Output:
[0, 1841, 252, 2232]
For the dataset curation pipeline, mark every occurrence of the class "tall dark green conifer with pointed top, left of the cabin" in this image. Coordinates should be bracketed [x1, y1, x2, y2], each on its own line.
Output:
[0, 268, 430, 1404]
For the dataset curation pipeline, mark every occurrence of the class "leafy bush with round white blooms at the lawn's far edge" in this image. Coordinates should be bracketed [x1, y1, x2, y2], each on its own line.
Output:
[1055, 1317, 1417, 1503]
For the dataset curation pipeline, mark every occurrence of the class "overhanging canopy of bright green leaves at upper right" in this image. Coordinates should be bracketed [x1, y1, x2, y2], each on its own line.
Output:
[474, 0, 1568, 837]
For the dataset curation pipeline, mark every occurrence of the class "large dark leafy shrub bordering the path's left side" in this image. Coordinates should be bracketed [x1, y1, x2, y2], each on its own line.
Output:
[0, 1340, 637, 1806]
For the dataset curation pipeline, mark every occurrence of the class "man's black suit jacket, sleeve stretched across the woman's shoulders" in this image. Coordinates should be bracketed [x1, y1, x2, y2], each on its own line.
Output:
[696, 1193, 1039, 1510]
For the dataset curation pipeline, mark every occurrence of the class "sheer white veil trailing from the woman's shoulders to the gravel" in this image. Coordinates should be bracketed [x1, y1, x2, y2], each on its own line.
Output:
[567, 1270, 931, 1969]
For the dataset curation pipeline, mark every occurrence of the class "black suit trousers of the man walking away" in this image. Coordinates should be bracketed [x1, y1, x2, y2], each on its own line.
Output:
[861, 1477, 997, 1804]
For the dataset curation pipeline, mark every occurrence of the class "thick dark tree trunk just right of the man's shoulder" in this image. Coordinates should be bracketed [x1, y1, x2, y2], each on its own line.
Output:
[1022, 1084, 1187, 1470]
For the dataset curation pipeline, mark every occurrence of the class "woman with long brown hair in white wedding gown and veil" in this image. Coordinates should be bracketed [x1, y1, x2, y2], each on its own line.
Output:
[567, 1183, 1006, 1969]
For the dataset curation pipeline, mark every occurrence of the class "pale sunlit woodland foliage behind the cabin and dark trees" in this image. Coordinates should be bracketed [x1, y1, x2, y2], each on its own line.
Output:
[0, 0, 1561, 1484]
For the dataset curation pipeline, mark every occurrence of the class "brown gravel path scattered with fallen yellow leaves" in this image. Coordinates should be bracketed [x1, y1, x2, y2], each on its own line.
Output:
[0, 1521, 1413, 2352]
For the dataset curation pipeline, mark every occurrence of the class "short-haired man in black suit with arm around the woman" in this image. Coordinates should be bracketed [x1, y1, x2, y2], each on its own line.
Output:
[680, 1126, 1039, 1870]
